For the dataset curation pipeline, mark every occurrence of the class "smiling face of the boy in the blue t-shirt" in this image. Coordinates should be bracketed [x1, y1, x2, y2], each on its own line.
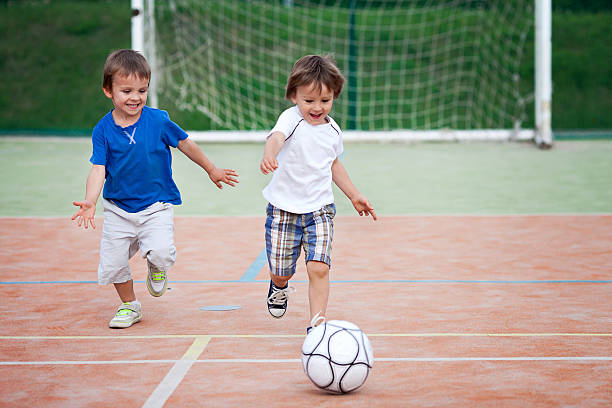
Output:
[103, 75, 149, 127]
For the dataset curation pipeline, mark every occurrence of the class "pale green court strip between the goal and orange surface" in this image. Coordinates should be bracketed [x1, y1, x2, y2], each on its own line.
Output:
[0, 138, 612, 217]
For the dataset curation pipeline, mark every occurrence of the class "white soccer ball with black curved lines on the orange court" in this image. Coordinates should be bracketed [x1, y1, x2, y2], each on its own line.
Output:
[302, 320, 374, 394]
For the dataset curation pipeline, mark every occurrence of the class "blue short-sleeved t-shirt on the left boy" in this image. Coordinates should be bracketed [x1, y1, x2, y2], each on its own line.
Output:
[89, 106, 188, 213]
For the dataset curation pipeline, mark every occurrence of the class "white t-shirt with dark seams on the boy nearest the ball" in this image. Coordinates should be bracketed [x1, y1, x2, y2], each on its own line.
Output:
[263, 106, 344, 214]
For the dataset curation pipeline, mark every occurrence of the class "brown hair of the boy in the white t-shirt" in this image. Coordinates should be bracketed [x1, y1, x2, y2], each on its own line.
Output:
[285, 55, 344, 99]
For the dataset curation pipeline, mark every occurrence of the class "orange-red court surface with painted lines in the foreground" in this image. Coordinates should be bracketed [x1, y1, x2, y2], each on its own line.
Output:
[0, 215, 612, 408]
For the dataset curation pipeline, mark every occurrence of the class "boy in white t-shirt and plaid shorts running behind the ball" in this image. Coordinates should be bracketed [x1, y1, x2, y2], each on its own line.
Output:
[260, 55, 377, 331]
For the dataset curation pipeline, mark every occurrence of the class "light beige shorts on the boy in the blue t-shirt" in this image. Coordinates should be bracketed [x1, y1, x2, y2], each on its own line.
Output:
[98, 199, 176, 285]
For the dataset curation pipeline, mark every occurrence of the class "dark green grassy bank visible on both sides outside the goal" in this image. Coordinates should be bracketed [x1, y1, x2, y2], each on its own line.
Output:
[0, 0, 612, 133]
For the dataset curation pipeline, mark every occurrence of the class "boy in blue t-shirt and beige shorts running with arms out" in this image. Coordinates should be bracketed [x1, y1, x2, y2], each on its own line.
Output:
[72, 50, 238, 328]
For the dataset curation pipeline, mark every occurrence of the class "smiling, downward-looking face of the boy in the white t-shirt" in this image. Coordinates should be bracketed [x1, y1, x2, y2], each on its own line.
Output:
[291, 82, 334, 125]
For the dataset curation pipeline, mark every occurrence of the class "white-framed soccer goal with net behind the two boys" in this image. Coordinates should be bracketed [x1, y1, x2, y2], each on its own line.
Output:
[131, 0, 552, 147]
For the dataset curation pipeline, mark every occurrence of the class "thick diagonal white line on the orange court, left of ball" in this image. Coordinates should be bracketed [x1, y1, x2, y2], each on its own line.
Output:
[143, 336, 211, 408]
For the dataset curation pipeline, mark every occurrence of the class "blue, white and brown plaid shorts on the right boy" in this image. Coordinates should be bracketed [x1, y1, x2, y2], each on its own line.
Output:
[266, 203, 336, 276]
